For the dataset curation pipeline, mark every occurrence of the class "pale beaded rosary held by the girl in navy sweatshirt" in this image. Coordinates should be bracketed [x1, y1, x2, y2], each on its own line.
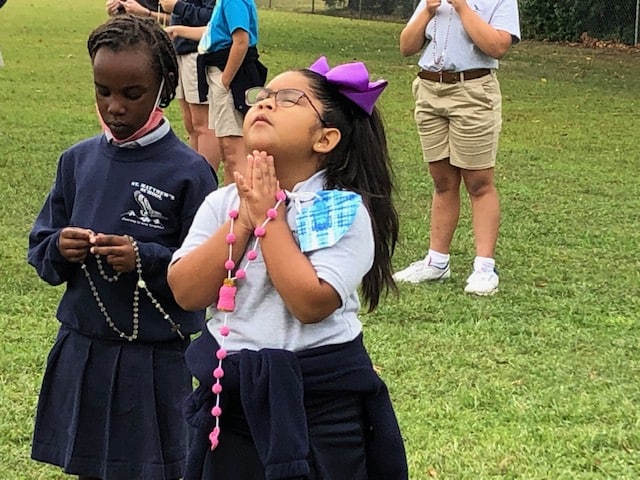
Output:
[80, 235, 184, 342]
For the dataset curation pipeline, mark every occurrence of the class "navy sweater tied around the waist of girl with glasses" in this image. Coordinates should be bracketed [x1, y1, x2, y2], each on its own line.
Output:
[184, 329, 409, 480]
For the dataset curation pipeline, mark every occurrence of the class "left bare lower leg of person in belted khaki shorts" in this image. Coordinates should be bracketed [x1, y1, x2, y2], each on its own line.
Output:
[429, 158, 461, 254]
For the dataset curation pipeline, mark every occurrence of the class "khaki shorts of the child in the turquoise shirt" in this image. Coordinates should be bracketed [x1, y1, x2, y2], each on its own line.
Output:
[207, 67, 244, 137]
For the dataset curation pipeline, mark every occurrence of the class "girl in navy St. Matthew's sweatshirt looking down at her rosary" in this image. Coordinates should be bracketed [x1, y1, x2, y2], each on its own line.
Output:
[28, 15, 216, 480]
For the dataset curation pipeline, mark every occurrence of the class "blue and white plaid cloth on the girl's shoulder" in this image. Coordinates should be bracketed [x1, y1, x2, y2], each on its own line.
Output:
[296, 190, 362, 252]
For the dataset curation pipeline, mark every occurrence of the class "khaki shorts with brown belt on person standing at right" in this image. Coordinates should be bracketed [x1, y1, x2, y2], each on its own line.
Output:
[412, 72, 502, 170]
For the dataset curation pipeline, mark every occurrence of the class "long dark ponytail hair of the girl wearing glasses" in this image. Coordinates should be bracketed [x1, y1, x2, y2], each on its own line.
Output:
[301, 70, 399, 312]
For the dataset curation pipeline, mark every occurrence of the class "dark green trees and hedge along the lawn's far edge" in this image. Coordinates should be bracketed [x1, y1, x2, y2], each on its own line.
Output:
[318, 0, 638, 45]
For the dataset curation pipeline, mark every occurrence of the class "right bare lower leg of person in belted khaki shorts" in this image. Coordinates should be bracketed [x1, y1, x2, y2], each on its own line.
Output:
[462, 168, 500, 258]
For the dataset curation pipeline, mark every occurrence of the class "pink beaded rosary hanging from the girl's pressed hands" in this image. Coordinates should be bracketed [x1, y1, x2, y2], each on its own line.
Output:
[209, 190, 287, 450]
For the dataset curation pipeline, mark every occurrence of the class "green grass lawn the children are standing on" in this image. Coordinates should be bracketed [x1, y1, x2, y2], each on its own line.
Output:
[0, 0, 640, 480]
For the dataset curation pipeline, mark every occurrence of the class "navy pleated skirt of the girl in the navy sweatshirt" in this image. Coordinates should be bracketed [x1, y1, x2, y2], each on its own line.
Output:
[31, 326, 192, 480]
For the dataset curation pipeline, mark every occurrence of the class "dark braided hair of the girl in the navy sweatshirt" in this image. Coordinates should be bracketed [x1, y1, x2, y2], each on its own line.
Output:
[87, 14, 178, 108]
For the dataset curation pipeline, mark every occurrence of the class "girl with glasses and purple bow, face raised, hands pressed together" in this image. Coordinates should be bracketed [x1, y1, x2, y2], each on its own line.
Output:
[168, 57, 408, 480]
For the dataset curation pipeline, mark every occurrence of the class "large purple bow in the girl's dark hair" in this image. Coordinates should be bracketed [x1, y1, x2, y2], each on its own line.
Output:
[307, 56, 389, 115]
